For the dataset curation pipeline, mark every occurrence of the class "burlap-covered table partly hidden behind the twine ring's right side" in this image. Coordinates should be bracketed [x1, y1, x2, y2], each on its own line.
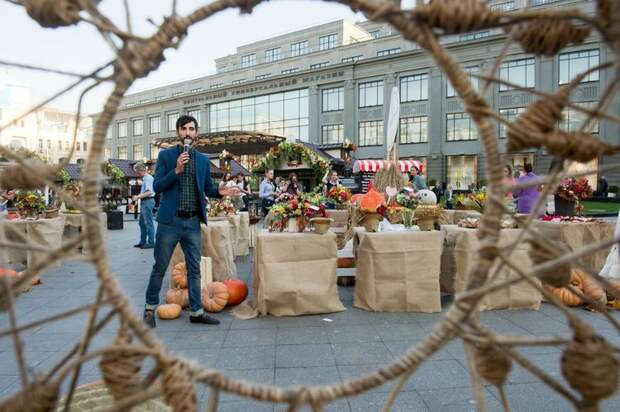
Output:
[441, 225, 541, 310]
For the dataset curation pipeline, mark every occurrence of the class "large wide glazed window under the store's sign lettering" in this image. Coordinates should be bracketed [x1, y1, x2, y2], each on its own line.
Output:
[209, 89, 310, 142]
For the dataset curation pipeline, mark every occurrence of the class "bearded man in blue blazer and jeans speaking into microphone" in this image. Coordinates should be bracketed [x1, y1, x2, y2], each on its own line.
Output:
[144, 116, 235, 328]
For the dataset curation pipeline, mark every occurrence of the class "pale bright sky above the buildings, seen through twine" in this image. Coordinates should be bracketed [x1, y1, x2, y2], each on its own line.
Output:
[0, 0, 413, 113]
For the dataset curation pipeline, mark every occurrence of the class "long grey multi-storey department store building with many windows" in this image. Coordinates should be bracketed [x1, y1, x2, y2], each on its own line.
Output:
[101, 0, 620, 189]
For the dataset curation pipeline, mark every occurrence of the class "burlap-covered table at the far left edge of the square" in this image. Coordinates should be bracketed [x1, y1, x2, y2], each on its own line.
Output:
[0, 216, 65, 267]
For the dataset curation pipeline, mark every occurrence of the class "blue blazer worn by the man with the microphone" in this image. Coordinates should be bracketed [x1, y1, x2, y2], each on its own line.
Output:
[153, 146, 220, 225]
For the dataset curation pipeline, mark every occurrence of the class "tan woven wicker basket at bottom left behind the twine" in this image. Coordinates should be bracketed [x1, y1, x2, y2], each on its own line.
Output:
[56, 381, 172, 412]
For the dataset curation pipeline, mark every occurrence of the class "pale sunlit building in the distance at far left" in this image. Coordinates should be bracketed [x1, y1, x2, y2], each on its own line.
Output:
[0, 74, 92, 163]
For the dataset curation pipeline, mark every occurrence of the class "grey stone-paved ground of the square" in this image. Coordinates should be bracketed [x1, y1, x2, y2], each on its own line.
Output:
[0, 221, 620, 412]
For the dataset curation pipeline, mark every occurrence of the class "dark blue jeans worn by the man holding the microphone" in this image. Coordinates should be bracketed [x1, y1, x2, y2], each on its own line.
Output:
[145, 216, 204, 316]
